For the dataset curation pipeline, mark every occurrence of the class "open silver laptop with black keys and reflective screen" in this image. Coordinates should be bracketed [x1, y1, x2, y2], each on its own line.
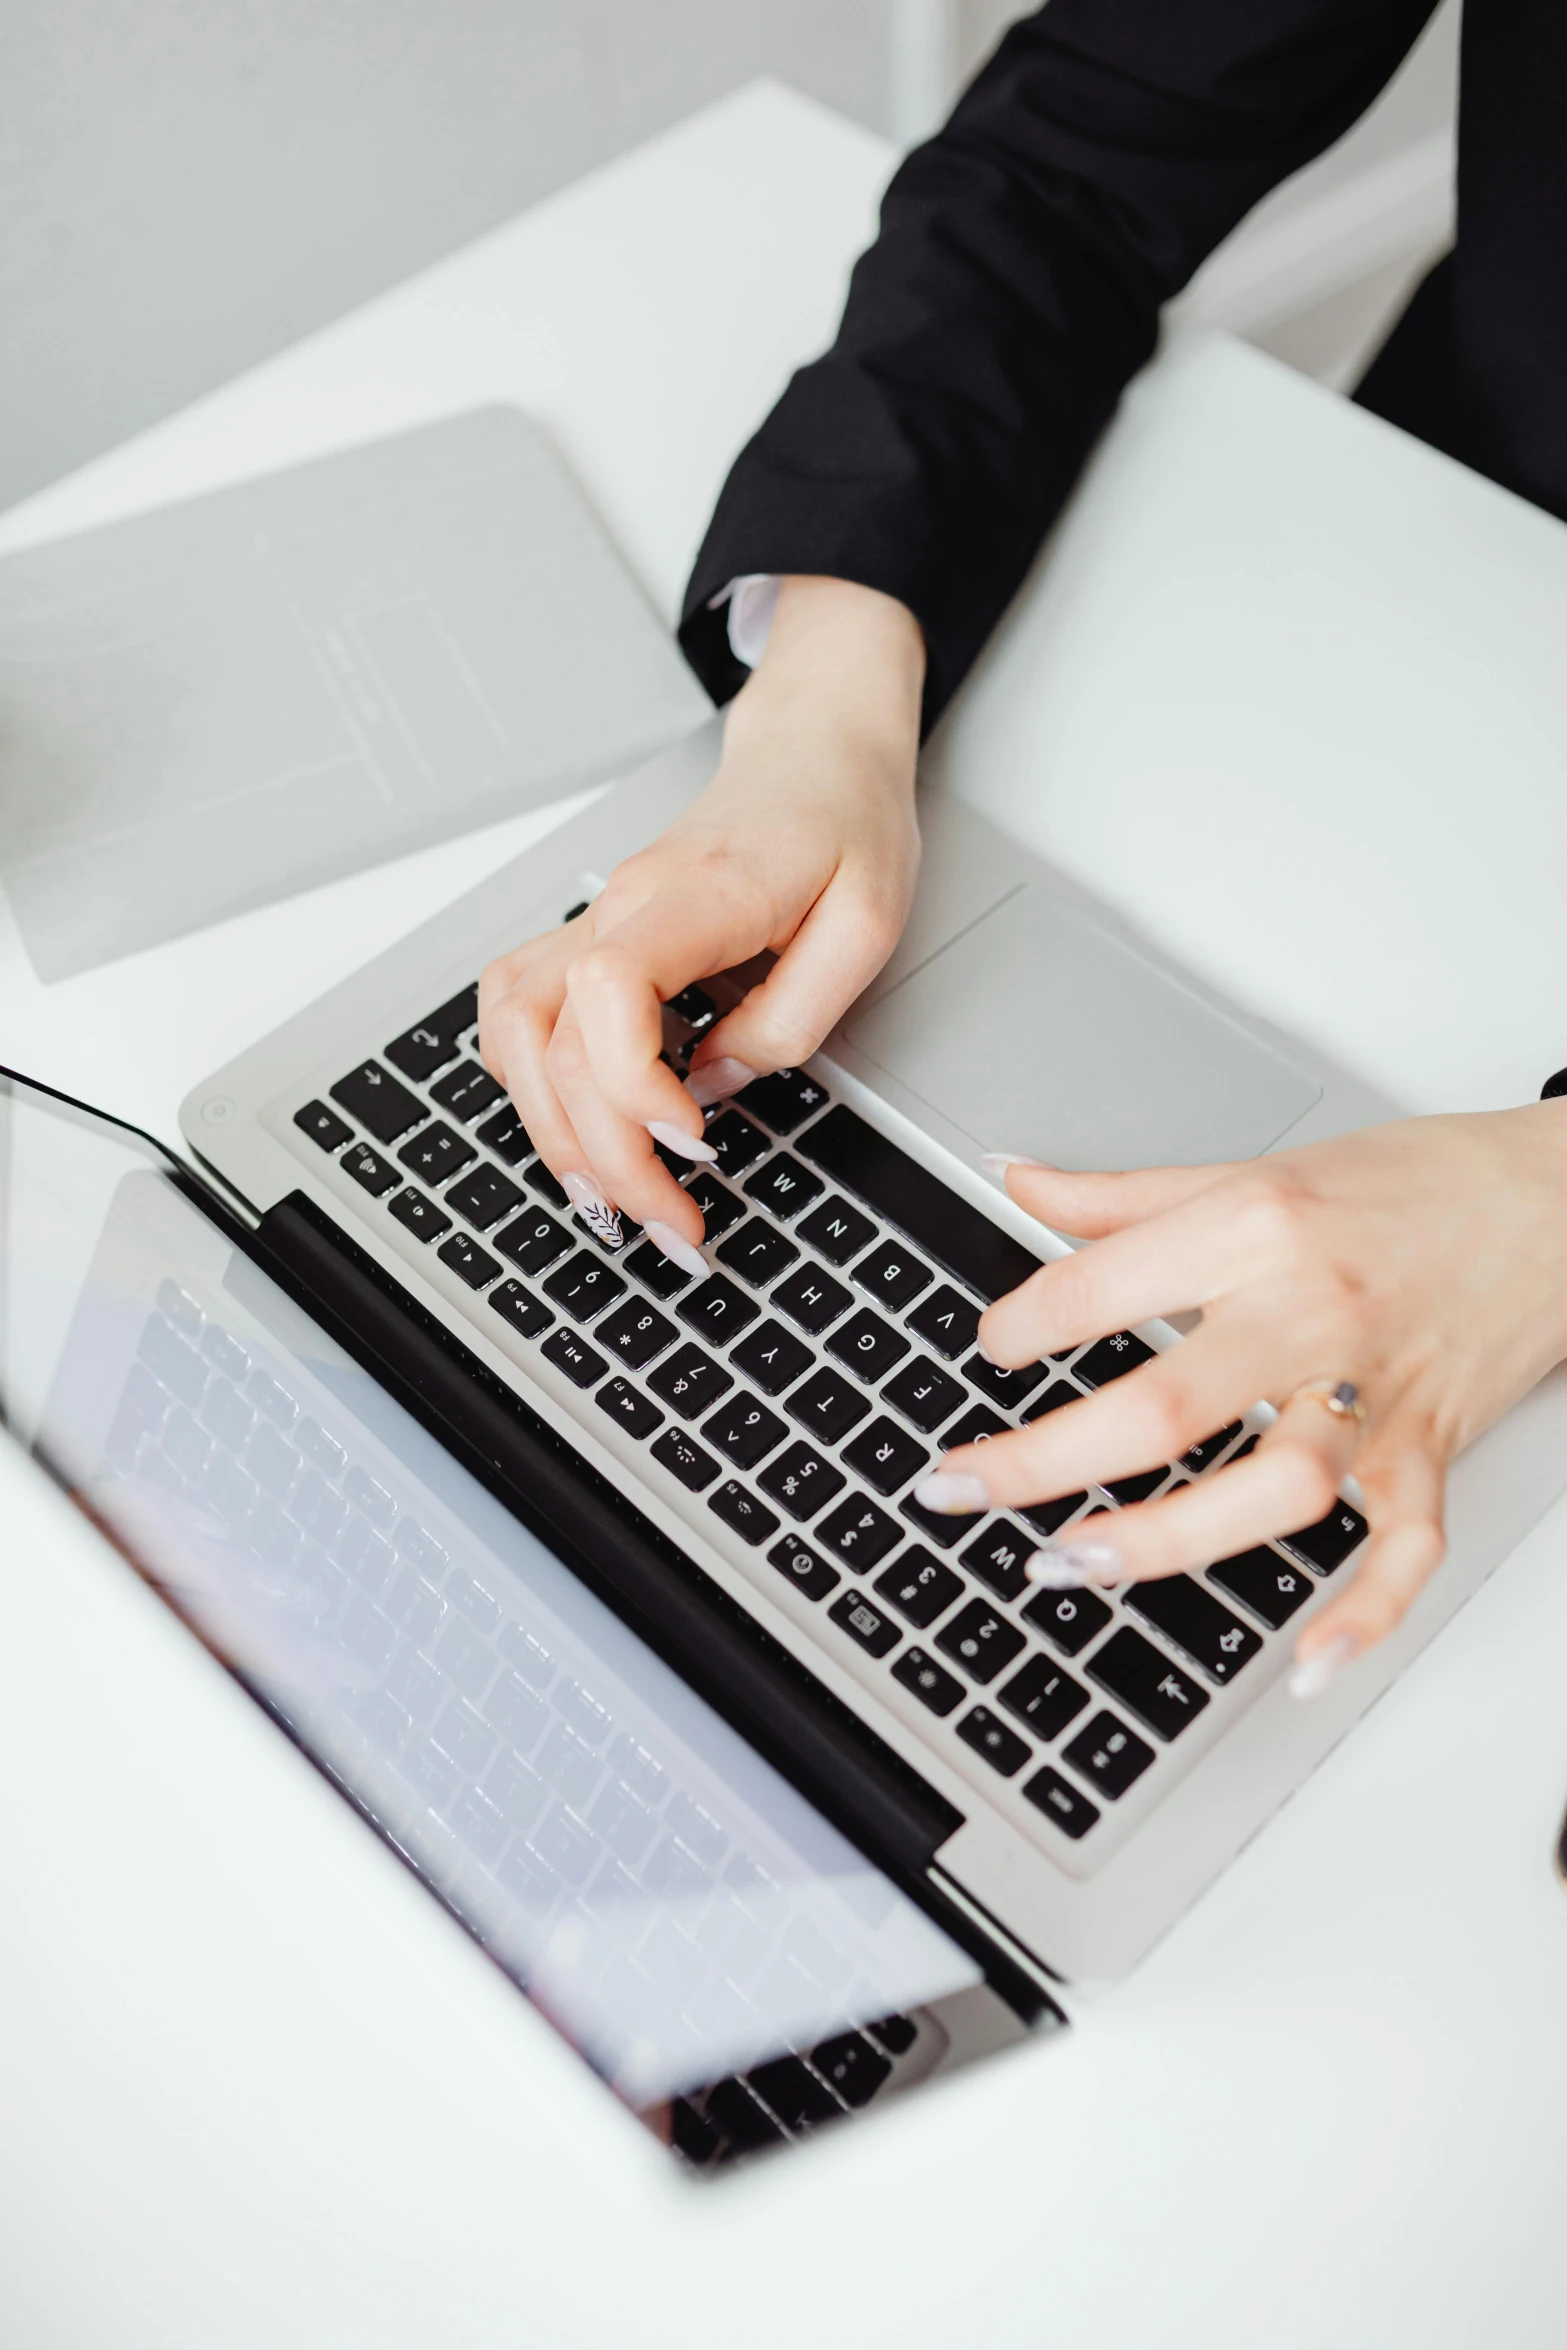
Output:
[7, 721, 1567, 2169]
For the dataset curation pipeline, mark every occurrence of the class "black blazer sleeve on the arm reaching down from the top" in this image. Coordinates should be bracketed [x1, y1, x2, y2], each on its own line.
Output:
[681, 0, 1433, 726]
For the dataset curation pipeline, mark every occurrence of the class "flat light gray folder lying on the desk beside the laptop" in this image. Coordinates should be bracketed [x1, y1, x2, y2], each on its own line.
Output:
[0, 407, 709, 980]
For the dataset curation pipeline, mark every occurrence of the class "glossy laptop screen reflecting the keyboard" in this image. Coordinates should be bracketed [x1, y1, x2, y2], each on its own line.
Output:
[0, 1081, 1022, 2164]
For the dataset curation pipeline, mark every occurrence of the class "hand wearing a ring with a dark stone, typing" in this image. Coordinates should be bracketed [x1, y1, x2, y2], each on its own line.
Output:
[919, 1102, 1567, 1694]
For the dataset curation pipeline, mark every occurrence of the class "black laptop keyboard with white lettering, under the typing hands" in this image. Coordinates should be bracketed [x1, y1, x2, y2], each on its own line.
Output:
[294, 987, 1365, 1845]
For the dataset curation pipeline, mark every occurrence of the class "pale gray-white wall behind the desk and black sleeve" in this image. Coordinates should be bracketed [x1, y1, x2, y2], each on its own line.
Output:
[0, 0, 1454, 505]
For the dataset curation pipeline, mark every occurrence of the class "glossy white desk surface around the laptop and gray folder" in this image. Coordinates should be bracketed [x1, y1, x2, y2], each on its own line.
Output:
[0, 87, 1567, 2350]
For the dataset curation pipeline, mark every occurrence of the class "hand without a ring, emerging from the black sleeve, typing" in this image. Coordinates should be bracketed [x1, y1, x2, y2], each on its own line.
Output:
[479, 578, 926, 1269]
